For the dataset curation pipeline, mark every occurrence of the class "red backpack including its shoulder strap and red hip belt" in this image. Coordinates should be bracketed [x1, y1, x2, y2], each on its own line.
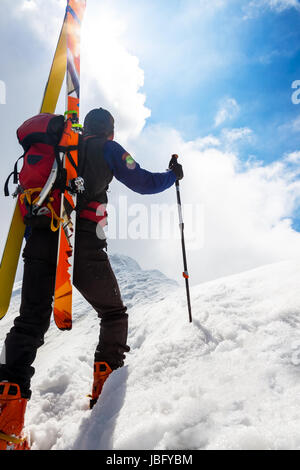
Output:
[4, 113, 107, 231]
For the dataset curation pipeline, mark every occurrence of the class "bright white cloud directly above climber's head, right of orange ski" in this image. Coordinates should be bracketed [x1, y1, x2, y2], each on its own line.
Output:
[82, 2, 150, 141]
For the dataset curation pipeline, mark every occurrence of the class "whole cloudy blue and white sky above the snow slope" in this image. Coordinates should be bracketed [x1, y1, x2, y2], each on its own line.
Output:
[0, 0, 300, 284]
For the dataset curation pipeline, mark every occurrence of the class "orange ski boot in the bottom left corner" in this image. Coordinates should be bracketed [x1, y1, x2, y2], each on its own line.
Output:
[0, 382, 29, 450]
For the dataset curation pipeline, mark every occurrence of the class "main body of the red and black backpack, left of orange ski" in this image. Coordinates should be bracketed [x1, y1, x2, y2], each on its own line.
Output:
[4, 113, 65, 231]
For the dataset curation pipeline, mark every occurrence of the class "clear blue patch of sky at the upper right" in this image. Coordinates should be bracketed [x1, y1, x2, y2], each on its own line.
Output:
[122, 0, 300, 162]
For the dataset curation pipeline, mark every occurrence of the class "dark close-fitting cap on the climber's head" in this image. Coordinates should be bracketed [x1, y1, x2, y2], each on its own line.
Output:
[84, 108, 115, 137]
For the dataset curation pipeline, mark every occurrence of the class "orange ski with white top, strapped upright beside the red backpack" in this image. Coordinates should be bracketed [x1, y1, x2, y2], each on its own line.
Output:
[53, 0, 86, 330]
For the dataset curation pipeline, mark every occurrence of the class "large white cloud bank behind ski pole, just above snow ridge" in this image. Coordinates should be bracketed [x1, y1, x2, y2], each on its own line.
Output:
[106, 126, 300, 283]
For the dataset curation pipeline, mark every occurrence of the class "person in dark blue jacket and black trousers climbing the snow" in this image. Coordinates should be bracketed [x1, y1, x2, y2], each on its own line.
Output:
[0, 108, 183, 449]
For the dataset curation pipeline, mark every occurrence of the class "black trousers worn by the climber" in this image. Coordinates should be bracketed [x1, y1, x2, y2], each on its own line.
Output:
[0, 229, 129, 398]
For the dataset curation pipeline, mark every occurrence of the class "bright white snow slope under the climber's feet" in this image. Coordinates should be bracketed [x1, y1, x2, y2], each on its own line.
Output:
[0, 255, 300, 450]
